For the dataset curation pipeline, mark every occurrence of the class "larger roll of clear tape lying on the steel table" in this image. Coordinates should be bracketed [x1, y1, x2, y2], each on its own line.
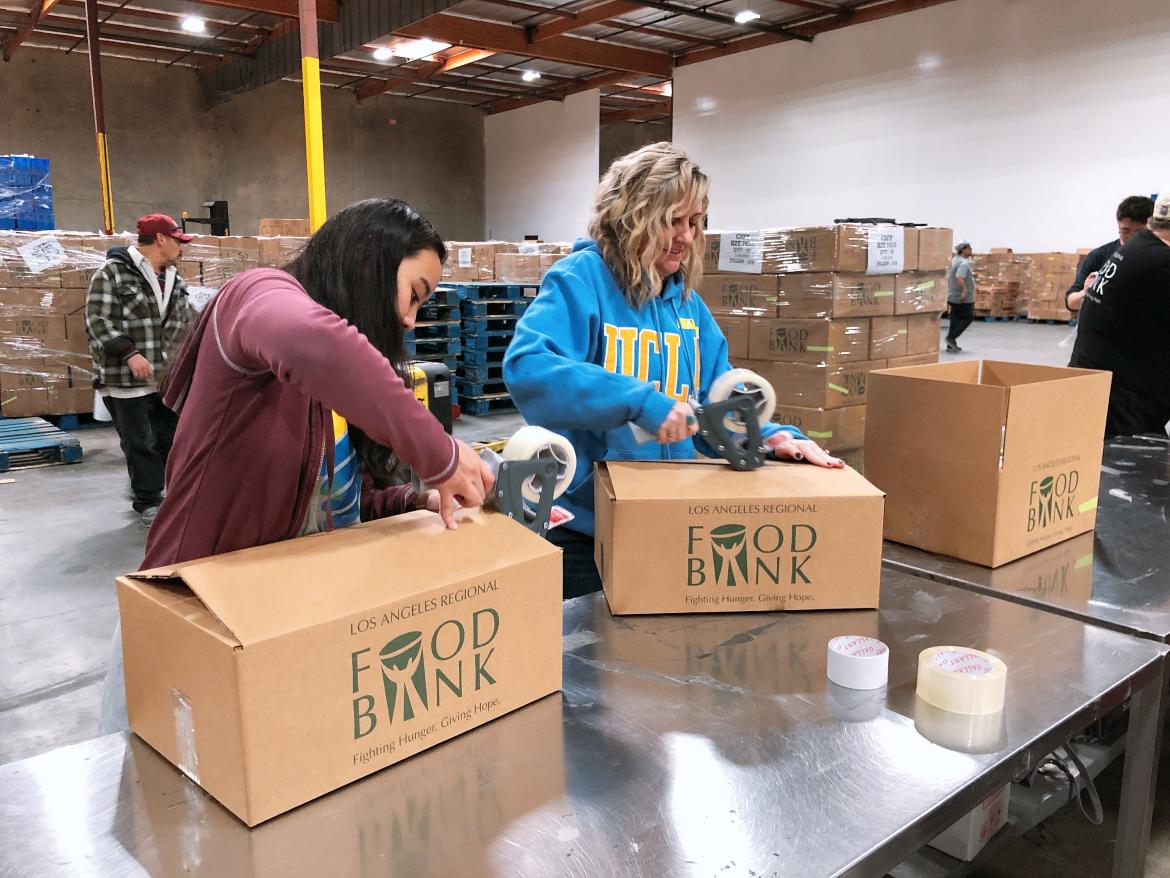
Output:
[917, 646, 1007, 714]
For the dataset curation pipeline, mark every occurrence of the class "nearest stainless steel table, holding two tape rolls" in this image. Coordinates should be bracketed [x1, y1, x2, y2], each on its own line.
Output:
[0, 570, 1168, 878]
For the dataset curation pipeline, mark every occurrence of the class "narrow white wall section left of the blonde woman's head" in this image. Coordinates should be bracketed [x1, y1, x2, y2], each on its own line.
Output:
[486, 90, 600, 241]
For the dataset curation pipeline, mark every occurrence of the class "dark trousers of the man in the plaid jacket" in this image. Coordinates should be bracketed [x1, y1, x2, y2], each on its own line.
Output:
[104, 393, 179, 512]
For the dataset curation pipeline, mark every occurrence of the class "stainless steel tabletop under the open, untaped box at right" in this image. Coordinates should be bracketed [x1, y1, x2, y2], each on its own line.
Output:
[882, 437, 1170, 643]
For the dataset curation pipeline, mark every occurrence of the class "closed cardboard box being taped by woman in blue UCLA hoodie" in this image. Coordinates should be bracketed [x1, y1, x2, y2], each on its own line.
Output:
[594, 460, 882, 615]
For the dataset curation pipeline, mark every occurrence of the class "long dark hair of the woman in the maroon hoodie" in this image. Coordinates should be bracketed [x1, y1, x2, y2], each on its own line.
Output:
[284, 198, 447, 485]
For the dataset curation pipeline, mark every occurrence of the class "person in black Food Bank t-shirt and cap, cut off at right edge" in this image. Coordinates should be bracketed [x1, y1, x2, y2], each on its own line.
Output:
[1068, 188, 1170, 438]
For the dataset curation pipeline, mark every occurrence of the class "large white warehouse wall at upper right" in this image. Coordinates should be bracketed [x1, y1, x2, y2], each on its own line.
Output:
[674, 0, 1170, 251]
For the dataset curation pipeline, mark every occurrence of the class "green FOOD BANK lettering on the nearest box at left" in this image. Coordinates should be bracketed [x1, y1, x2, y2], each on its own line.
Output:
[350, 608, 500, 740]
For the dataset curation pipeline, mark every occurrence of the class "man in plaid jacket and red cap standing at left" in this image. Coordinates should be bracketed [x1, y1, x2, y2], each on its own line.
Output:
[85, 213, 195, 527]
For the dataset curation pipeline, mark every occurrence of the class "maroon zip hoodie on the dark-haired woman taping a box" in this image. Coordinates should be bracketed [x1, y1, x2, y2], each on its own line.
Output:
[143, 268, 459, 569]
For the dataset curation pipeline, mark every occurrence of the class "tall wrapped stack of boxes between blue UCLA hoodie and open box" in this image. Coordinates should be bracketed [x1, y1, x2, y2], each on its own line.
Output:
[700, 225, 954, 475]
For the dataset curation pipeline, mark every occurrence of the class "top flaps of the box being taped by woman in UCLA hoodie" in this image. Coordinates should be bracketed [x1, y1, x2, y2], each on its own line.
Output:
[605, 460, 882, 502]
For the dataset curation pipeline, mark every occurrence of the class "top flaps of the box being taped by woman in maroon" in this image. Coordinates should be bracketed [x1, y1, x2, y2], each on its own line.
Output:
[123, 510, 558, 647]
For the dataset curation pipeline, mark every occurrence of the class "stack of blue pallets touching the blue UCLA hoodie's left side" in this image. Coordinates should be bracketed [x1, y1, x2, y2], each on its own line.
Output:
[456, 283, 535, 416]
